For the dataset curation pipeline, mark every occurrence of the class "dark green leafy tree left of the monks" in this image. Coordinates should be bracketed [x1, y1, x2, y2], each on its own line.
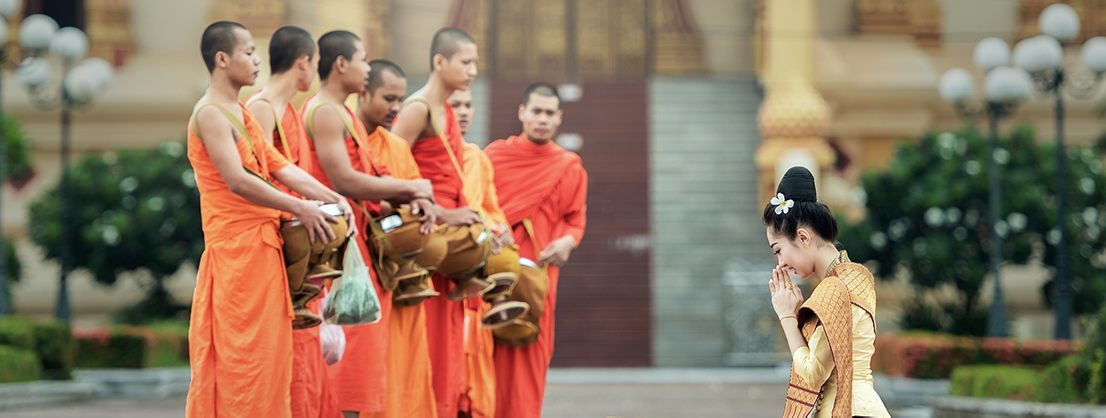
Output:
[30, 142, 204, 321]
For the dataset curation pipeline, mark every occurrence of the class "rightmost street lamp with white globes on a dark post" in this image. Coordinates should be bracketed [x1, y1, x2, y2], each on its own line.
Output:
[1014, 3, 1106, 339]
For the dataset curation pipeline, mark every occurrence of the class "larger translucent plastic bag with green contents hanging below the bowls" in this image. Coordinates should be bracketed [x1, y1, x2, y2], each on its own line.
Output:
[323, 239, 380, 325]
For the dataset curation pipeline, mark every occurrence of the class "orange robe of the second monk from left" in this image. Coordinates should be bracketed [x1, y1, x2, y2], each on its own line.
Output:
[246, 88, 342, 418]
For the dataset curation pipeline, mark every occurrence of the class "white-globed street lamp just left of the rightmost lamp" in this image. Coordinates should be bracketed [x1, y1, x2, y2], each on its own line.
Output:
[937, 38, 1033, 337]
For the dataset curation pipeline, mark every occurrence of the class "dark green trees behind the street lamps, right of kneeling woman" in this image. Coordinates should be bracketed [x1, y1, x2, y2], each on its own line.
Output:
[841, 126, 1106, 335]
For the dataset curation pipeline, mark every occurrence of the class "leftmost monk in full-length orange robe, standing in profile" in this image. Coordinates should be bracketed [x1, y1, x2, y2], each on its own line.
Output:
[186, 21, 352, 417]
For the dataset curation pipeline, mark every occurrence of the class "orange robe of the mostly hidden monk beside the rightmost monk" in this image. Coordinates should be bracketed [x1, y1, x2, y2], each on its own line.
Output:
[461, 143, 507, 418]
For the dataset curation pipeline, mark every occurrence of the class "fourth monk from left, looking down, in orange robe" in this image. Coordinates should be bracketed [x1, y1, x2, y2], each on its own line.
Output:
[357, 60, 440, 418]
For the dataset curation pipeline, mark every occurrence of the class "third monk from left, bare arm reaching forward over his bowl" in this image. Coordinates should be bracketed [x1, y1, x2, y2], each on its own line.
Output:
[303, 31, 435, 417]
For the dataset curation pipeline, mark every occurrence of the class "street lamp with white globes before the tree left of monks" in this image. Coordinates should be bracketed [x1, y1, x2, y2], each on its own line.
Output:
[15, 14, 114, 323]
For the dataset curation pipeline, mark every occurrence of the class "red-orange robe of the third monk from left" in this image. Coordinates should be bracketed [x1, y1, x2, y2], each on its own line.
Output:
[302, 100, 392, 416]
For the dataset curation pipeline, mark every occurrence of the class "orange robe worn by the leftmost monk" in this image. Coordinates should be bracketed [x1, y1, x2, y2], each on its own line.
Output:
[186, 104, 292, 417]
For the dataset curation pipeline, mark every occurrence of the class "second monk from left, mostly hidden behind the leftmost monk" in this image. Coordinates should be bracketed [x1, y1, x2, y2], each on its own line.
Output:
[246, 27, 342, 418]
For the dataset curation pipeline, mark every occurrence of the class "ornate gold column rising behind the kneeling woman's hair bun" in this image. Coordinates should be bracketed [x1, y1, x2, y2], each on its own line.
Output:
[755, 0, 835, 203]
